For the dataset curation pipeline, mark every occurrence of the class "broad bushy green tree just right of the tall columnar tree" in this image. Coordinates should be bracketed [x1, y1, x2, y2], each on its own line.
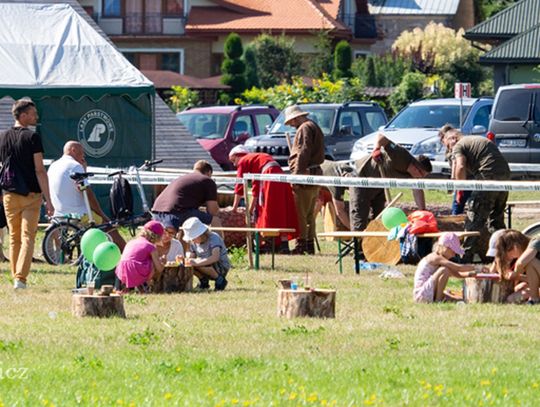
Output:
[253, 34, 302, 88]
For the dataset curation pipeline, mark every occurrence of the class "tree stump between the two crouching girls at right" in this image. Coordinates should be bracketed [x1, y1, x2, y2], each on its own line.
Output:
[463, 277, 514, 304]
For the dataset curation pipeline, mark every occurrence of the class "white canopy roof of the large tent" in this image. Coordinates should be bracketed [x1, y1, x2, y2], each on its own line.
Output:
[0, 3, 154, 100]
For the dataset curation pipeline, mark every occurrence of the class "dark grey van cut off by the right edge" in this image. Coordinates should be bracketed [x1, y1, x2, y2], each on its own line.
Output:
[487, 84, 540, 164]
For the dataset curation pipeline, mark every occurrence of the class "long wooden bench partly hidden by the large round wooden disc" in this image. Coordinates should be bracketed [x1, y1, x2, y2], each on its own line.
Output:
[317, 231, 480, 274]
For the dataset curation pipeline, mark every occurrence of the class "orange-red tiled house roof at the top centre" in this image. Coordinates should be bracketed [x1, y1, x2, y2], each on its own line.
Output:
[186, 0, 350, 34]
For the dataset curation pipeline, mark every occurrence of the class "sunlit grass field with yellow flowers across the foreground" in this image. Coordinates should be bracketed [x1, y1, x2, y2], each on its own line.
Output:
[0, 198, 540, 406]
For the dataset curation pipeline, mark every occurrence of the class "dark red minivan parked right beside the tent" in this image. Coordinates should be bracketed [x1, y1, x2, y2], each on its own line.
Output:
[176, 105, 279, 170]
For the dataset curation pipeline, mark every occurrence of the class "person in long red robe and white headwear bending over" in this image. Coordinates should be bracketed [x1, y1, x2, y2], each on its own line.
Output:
[229, 145, 299, 253]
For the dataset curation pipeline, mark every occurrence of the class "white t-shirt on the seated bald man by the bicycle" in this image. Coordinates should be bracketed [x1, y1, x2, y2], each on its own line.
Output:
[47, 155, 87, 216]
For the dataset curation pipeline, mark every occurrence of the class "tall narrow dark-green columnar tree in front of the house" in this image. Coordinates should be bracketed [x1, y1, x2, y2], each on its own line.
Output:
[221, 33, 246, 95]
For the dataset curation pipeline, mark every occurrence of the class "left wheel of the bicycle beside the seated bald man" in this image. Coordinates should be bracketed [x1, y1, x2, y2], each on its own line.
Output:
[41, 223, 81, 265]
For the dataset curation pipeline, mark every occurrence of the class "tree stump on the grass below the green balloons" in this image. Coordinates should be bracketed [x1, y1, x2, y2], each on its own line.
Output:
[71, 294, 126, 318]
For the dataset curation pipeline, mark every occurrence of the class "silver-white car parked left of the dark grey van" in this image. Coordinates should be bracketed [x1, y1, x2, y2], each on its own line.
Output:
[350, 97, 493, 169]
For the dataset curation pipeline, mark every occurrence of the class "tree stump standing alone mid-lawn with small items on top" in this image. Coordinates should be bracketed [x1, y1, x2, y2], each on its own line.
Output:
[278, 289, 336, 318]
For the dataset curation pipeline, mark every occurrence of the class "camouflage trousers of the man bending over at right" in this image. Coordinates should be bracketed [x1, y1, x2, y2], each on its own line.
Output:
[463, 191, 508, 263]
